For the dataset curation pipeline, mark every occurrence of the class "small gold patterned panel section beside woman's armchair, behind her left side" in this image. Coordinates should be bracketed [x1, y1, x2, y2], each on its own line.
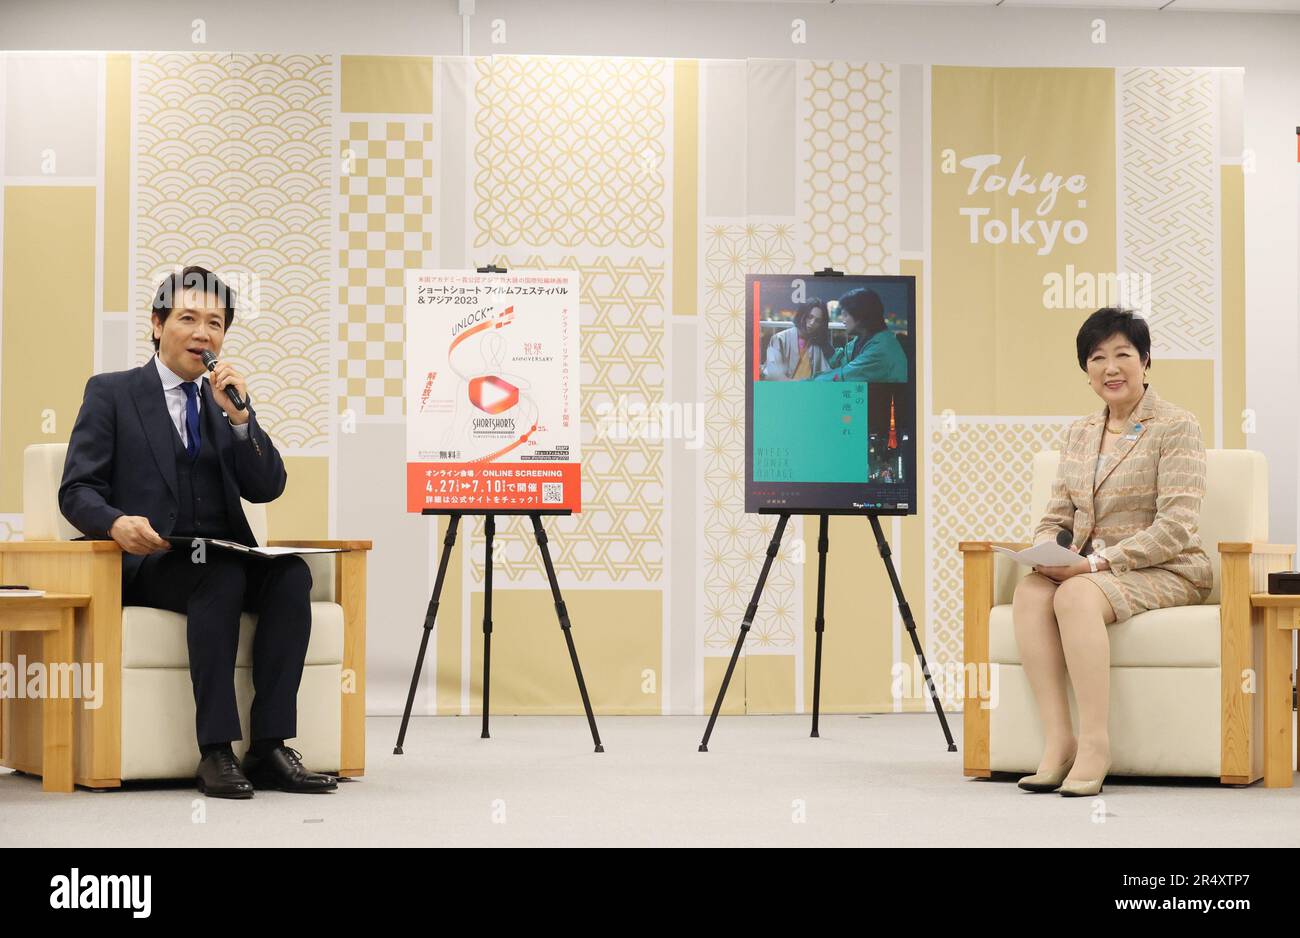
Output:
[926, 416, 1069, 707]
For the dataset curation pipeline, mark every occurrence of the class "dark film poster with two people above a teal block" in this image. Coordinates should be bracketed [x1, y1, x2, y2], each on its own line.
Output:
[745, 273, 918, 514]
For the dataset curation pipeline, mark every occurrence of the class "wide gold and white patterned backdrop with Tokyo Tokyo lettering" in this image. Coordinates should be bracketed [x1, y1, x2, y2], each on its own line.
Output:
[0, 53, 1245, 713]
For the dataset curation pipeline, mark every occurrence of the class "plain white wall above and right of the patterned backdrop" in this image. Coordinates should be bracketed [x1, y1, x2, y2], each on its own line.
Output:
[0, 0, 1300, 542]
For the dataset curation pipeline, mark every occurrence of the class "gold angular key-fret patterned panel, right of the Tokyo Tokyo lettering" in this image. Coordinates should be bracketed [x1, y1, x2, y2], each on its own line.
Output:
[1118, 69, 1219, 357]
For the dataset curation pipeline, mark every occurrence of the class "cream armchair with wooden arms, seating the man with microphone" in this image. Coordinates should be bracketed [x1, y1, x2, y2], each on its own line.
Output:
[0, 444, 371, 789]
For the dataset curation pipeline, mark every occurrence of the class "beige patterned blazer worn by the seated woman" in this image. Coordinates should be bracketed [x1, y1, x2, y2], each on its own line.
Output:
[1034, 386, 1213, 590]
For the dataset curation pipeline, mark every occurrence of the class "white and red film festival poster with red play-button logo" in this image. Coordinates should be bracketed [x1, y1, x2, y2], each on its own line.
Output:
[406, 270, 581, 513]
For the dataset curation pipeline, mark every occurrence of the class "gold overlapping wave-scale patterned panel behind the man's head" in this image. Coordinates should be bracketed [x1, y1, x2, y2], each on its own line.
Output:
[133, 52, 334, 450]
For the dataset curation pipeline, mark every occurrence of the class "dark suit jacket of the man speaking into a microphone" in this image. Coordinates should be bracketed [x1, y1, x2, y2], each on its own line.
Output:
[59, 359, 289, 581]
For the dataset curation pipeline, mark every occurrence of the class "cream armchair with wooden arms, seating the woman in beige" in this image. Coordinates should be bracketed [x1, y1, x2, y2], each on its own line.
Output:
[959, 450, 1295, 785]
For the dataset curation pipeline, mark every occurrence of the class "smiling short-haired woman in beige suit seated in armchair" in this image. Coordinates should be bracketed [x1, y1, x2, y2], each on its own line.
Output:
[1011, 309, 1212, 795]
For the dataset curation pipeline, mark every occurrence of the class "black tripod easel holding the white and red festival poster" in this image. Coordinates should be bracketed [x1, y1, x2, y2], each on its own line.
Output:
[393, 264, 605, 756]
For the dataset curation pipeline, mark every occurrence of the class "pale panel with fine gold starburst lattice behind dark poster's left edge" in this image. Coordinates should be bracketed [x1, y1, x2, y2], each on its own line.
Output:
[699, 221, 803, 653]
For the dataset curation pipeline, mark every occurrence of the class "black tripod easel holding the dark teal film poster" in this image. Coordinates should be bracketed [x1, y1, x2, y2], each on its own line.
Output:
[699, 268, 957, 752]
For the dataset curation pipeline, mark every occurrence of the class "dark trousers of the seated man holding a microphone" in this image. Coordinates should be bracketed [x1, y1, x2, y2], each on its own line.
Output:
[122, 547, 312, 746]
